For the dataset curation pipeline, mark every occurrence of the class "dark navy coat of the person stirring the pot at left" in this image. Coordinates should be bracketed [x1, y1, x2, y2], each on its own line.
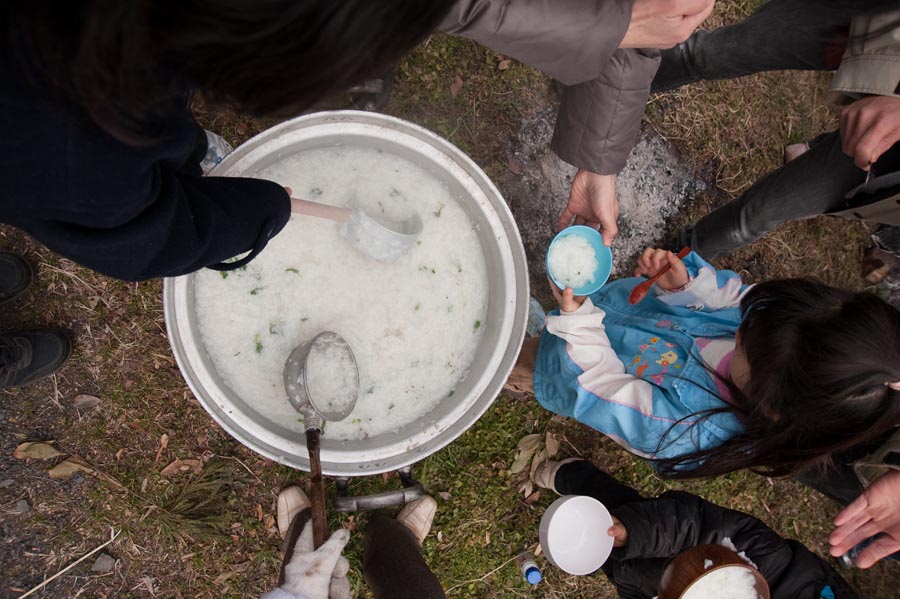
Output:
[0, 55, 290, 281]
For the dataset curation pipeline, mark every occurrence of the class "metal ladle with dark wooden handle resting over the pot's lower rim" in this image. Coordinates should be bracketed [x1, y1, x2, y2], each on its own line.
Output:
[284, 331, 359, 548]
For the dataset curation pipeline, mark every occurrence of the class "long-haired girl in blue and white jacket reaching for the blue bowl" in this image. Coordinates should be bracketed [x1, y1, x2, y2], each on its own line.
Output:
[520, 249, 900, 476]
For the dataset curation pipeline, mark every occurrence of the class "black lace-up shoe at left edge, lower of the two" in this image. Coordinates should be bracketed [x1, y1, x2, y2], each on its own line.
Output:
[0, 329, 72, 388]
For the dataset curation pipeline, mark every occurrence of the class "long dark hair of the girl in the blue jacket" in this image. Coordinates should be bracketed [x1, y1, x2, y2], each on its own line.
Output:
[657, 279, 900, 478]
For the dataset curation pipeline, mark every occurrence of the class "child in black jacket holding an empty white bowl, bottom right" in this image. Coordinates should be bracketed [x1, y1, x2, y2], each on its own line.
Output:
[535, 460, 860, 599]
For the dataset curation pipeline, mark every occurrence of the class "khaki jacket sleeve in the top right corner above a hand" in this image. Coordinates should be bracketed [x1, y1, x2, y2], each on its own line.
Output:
[826, 9, 900, 104]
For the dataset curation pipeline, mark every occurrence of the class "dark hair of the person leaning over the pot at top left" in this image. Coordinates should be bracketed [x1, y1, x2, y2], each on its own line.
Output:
[0, 0, 454, 142]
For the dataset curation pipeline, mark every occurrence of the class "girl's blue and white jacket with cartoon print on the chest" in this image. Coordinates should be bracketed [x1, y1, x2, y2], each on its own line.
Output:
[534, 253, 748, 459]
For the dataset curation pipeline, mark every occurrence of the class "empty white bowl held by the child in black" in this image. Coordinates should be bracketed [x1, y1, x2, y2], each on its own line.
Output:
[540, 495, 615, 576]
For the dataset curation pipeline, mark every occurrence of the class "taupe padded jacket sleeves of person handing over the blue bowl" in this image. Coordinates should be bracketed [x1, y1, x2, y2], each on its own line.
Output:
[441, 0, 659, 174]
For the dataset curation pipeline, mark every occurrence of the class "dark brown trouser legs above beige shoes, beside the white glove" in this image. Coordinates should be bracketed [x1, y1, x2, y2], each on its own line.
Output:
[278, 508, 446, 599]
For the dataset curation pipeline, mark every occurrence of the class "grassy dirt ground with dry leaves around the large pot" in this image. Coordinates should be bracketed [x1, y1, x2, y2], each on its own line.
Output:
[0, 3, 900, 599]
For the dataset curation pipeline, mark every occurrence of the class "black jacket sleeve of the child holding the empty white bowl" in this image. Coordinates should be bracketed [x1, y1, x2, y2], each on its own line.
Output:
[613, 491, 857, 599]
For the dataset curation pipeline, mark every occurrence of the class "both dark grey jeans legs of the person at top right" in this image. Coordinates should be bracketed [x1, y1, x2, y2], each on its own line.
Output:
[652, 0, 891, 260]
